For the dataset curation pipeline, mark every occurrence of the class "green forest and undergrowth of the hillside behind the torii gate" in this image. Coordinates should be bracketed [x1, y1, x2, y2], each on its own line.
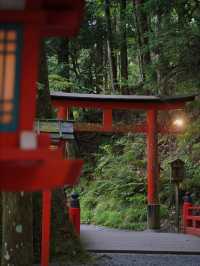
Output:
[38, 0, 200, 231]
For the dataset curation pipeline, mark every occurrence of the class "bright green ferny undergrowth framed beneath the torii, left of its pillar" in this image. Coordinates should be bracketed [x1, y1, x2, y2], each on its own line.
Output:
[80, 134, 147, 230]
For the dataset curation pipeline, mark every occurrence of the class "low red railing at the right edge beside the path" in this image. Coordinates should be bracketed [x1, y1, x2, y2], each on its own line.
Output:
[183, 202, 200, 236]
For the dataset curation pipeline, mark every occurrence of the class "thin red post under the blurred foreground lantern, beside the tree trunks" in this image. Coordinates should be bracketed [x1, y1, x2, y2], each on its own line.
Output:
[41, 190, 51, 266]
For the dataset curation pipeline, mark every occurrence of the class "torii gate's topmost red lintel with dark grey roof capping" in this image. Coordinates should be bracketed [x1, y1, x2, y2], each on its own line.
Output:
[51, 92, 195, 110]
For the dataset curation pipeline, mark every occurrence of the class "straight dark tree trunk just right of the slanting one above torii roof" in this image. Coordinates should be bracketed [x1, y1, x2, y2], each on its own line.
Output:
[120, 0, 128, 94]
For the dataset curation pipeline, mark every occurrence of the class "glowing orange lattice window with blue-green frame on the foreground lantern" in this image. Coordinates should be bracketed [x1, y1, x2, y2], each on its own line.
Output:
[0, 24, 21, 131]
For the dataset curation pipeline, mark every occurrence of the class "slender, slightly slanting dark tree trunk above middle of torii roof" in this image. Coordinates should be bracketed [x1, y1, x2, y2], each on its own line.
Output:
[105, 0, 117, 93]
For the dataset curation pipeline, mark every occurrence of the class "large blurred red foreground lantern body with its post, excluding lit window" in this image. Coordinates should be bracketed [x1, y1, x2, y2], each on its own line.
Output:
[0, 0, 84, 266]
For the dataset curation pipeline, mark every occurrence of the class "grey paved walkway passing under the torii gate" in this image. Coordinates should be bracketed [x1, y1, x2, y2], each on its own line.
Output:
[81, 225, 200, 255]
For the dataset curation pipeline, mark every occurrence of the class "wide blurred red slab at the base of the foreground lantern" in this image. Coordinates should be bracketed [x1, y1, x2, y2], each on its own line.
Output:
[0, 159, 83, 191]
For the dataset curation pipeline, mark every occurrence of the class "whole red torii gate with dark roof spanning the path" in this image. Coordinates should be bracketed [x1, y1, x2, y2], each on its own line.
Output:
[51, 92, 195, 229]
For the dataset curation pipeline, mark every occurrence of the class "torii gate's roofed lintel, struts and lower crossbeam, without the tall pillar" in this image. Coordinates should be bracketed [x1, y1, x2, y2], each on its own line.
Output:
[51, 92, 195, 133]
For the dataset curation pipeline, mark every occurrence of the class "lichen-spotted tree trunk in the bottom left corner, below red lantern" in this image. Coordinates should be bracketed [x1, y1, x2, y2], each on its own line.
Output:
[1, 192, 33, 266]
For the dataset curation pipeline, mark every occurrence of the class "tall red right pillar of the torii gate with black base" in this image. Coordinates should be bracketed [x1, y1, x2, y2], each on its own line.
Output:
[147, 110, 160, 229]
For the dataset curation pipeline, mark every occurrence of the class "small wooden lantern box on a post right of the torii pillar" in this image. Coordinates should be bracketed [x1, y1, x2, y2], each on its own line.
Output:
[170, 159, 185, 232]
